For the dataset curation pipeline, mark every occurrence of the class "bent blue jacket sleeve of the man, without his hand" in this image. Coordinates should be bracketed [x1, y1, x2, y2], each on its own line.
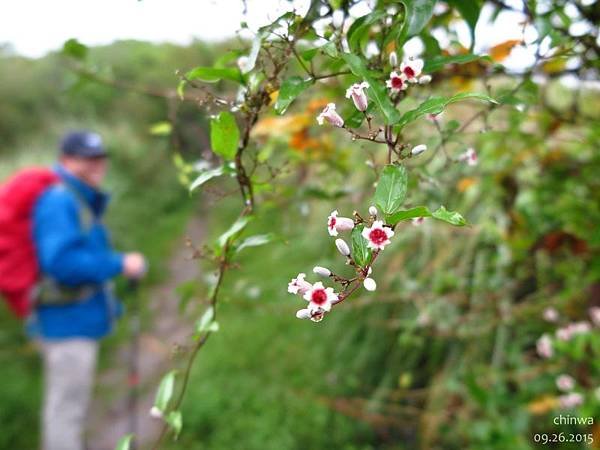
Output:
[33, 188, 123, 285]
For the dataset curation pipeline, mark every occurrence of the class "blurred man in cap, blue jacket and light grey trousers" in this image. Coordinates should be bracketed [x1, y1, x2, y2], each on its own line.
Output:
[30, 131, 145, 450]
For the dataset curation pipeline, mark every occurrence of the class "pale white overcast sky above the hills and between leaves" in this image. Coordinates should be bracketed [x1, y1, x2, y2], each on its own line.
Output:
[0, 0, 531, 68]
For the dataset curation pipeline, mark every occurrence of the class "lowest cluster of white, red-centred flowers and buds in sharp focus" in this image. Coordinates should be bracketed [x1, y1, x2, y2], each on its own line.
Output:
[288, 206, 394, 322]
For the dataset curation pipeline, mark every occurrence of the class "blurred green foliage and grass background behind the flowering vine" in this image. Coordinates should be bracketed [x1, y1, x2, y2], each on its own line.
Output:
[0, 1, 600, 450]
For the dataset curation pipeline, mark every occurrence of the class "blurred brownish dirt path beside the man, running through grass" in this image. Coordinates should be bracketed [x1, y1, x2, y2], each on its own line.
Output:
[88, 217, 204, 450]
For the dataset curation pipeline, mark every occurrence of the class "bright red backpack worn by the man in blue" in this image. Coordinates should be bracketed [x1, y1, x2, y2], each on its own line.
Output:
[0, 167, 60, 318]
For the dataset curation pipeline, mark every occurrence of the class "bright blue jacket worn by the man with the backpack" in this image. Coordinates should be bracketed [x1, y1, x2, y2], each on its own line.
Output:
[29, 165, 123, 339]
